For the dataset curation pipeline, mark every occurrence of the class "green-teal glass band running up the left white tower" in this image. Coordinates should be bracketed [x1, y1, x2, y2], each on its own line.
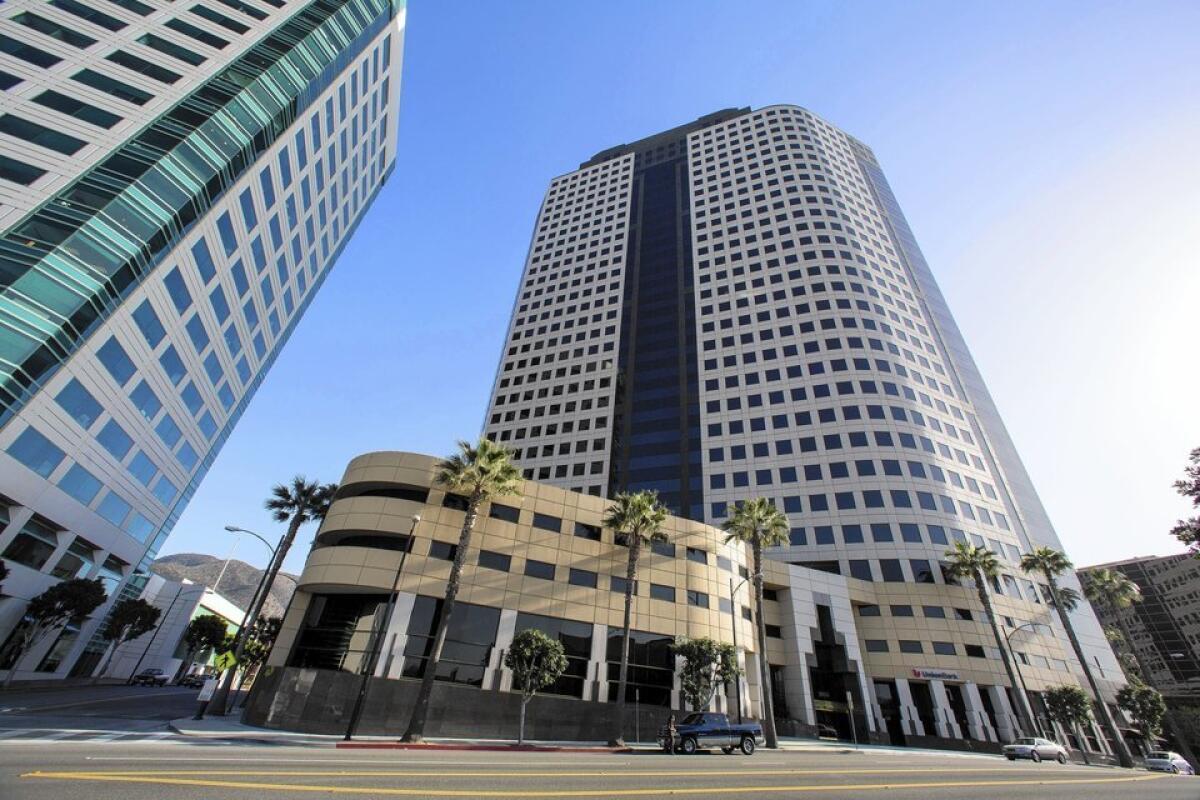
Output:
[0, 0, 395, 426]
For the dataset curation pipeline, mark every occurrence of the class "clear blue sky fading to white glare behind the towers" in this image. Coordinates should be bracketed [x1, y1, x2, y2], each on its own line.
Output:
[163, 0, 1200, 571]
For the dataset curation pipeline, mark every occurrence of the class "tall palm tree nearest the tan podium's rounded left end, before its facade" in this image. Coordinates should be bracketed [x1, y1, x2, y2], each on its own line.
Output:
[402, 439, 521, 741]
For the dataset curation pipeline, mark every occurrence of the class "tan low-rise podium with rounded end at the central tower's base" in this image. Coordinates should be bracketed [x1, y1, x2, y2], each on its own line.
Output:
[247, 452, 1100, 750]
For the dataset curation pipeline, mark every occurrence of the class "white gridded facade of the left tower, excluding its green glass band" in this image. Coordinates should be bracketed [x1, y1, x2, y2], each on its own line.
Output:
[0, 0, 404, 680]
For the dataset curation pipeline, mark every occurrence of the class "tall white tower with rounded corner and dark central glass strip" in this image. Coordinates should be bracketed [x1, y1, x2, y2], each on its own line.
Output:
[485, 106, 1123, 714]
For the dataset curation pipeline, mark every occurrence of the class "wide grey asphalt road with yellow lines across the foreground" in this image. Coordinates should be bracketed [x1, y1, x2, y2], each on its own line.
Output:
[0, 740, 1200, 800]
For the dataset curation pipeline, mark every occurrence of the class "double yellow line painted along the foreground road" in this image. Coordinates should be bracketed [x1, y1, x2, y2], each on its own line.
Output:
[22, 771, 1164, 798]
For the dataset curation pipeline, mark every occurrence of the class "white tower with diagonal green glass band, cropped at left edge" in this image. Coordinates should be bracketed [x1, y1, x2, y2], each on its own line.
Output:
[0, 0, 404, 679]
